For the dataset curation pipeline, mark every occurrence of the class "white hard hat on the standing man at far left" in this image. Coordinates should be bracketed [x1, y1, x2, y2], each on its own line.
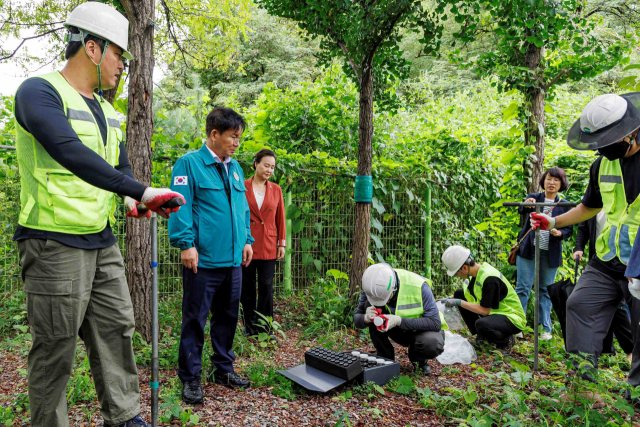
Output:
[64, 1, 133, 59]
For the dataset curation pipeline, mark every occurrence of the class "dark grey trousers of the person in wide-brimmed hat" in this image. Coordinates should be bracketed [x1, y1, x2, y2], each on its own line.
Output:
[567, 266, 640, 387]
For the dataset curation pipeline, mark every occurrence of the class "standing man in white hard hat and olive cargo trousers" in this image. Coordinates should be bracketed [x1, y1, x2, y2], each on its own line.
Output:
[14, 2, 184, 427]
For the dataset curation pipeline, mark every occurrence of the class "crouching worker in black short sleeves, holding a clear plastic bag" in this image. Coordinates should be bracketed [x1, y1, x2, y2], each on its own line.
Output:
[442, 246, 526, 352]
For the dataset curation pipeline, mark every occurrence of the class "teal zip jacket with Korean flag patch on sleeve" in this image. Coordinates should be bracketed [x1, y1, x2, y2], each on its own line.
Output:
[169, 145, 253, 268]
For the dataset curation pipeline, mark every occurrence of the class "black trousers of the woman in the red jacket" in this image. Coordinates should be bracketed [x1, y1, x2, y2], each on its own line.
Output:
[240, 259, 276, 335]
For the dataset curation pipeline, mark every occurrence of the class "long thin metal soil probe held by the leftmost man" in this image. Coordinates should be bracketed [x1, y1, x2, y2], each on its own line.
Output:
[149, 212, 159, 427]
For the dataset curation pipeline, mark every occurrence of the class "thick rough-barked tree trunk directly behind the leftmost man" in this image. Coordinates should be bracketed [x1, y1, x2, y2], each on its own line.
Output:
[121, 0, 155, 341]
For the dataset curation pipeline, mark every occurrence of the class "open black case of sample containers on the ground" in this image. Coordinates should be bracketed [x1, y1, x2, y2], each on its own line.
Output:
[278, 347, 400, 393]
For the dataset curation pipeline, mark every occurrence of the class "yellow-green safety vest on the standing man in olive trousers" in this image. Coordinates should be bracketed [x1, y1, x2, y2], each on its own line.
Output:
[16, 71, 123, 234]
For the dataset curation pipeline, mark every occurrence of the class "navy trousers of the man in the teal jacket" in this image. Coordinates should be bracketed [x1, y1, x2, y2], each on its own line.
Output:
[178, 267, 242, 382]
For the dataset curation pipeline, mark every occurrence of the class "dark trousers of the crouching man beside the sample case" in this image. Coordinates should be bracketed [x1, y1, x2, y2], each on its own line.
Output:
[369, 323, 444, 364]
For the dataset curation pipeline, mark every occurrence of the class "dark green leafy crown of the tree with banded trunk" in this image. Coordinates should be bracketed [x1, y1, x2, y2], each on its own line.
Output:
[260, 0, 441, 105]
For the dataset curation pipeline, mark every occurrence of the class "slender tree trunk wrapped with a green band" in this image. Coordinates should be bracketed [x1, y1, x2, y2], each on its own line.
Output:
[349, 59, 373, 295]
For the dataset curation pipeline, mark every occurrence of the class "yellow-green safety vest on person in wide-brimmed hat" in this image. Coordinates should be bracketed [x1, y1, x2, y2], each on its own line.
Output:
[596, 157, 640, 265]
